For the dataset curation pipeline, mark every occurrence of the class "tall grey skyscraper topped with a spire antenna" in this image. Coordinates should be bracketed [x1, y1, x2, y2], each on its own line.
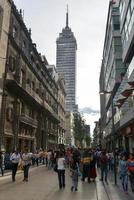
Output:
[56, 9, 77, 111]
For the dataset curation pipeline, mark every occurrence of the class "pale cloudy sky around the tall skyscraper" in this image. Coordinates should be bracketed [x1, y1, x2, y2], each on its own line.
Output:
[14, 0, 109, 134]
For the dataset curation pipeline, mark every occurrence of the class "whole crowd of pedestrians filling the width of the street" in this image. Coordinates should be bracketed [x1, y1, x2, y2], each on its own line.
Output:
[0, 148, 134, 196]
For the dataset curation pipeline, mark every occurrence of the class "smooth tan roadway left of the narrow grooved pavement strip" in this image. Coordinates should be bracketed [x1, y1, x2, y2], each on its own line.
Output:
[0, 166, 97, 200]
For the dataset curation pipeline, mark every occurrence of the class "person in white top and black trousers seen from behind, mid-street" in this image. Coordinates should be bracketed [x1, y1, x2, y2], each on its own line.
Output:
[57, 152, 65, 189]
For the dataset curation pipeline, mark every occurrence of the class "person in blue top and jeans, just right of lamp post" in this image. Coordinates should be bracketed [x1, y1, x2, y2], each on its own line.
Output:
[119, 156, 128, 193]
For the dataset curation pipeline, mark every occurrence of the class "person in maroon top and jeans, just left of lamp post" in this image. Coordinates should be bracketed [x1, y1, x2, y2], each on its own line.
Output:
[100, 151, 108, 183]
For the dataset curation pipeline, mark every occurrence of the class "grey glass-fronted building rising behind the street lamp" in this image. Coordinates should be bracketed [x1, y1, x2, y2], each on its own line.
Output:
[99, 0, 126, 150]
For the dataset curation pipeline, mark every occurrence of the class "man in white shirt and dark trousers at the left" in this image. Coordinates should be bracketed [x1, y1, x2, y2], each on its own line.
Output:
[10, 150, 21, 182]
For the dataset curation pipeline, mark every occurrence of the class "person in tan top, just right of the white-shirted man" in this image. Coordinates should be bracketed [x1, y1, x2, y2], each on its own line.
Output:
[22, 148, 32, 182]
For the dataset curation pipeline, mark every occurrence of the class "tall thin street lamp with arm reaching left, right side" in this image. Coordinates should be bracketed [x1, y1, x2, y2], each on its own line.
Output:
[100, 91, 117, 185]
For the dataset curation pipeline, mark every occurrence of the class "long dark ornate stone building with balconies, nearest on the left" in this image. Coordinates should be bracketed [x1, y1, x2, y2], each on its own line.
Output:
[0, 1, 59, 152]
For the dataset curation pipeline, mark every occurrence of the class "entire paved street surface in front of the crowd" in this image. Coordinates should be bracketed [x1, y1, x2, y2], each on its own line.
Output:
[0, 166, 133, 200]
